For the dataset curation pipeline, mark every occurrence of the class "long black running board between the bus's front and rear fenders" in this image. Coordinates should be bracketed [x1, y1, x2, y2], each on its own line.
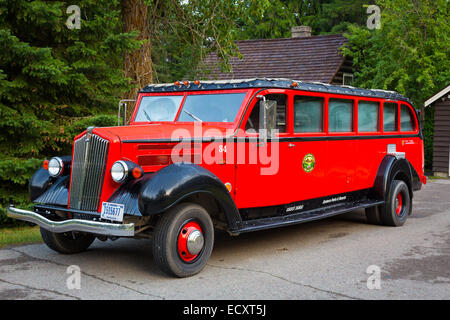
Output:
[231, 200, 384, 234]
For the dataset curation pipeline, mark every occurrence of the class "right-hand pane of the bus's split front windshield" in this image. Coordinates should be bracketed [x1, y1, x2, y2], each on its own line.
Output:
[178, 92, 246, 122]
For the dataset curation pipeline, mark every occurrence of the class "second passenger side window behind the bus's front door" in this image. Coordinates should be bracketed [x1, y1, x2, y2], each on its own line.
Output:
[328, 99, 353, 132]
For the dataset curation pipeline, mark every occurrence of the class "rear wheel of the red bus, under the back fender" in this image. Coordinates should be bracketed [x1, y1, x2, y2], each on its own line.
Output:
[380, 180, 412, 227]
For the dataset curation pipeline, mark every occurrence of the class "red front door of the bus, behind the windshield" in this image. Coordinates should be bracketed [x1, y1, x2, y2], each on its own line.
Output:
[235, 89, 290, 208]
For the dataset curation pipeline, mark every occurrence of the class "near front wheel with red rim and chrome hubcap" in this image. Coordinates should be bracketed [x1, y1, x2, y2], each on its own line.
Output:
[152, 203, 214, 278]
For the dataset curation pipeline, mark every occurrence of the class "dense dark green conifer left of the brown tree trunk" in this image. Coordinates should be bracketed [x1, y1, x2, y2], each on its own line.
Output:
[0, 0, 140, 223]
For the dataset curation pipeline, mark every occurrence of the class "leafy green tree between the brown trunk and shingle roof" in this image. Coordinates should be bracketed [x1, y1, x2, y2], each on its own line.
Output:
[149, 0, 270, 82]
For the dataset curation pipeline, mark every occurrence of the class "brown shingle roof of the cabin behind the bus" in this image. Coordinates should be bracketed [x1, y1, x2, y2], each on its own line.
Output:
[203, 35, 347, 83]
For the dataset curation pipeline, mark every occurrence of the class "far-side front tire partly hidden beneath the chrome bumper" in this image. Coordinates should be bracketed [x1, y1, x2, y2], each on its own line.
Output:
[40, 228, 95, 254]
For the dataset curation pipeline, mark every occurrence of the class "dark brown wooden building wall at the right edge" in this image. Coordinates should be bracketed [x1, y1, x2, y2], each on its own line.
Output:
[431, 97, 450, 176]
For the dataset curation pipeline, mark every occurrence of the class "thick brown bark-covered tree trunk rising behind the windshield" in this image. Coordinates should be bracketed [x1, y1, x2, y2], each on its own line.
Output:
[122, 0, 153, 103]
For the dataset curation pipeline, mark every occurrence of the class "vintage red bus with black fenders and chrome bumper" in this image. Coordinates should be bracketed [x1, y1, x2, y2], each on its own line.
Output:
[7, 79, 426, 277]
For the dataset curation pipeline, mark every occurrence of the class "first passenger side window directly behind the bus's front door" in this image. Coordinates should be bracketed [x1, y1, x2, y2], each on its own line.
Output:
[294, 96, 324, 132]
